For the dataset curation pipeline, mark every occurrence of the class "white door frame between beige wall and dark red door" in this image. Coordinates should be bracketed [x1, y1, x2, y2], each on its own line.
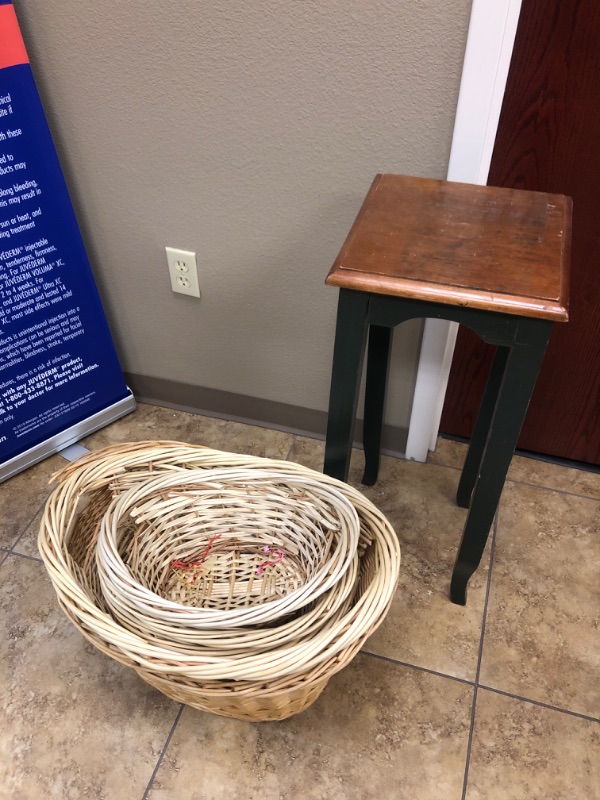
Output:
[406, 0, 521, 461]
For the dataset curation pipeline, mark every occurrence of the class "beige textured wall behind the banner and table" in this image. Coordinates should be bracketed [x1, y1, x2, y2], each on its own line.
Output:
[15, 0, 470, 432]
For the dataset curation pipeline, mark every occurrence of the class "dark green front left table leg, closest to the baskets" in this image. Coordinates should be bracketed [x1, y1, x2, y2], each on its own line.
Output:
[323, 289, 369, 481]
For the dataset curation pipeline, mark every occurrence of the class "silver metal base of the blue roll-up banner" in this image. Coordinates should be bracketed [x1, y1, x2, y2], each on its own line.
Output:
[0, 391, 136, 483]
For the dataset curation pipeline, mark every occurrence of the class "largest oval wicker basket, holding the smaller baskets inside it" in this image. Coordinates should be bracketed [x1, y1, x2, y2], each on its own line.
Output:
[39, 442, 400, 721]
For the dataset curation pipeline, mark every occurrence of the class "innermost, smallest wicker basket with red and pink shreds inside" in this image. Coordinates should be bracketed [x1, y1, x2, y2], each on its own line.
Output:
[97, 467, 360, 641]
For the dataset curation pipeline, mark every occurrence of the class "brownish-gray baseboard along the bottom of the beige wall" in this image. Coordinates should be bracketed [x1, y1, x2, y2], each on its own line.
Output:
[125, 372, 408, 457]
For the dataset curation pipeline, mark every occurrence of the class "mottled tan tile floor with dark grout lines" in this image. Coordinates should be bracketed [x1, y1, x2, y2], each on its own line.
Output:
[0, 405, 600, 800]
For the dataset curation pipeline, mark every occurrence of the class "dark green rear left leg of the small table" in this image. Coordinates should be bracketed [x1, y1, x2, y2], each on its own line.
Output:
[362, 325, 392, 486]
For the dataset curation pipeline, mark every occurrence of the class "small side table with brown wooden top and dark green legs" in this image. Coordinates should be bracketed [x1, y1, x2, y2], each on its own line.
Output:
[324, 175, 571, 605]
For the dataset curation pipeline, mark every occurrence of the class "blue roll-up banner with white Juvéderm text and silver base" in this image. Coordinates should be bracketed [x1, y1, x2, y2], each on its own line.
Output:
[0, 0, 135, 481]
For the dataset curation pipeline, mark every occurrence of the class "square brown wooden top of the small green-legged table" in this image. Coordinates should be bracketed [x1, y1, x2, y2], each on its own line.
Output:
[326, 174, 572, 321]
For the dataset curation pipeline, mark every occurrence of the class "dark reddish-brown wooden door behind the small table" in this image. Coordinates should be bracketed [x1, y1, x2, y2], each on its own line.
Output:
[441, 0, 600, 464]
